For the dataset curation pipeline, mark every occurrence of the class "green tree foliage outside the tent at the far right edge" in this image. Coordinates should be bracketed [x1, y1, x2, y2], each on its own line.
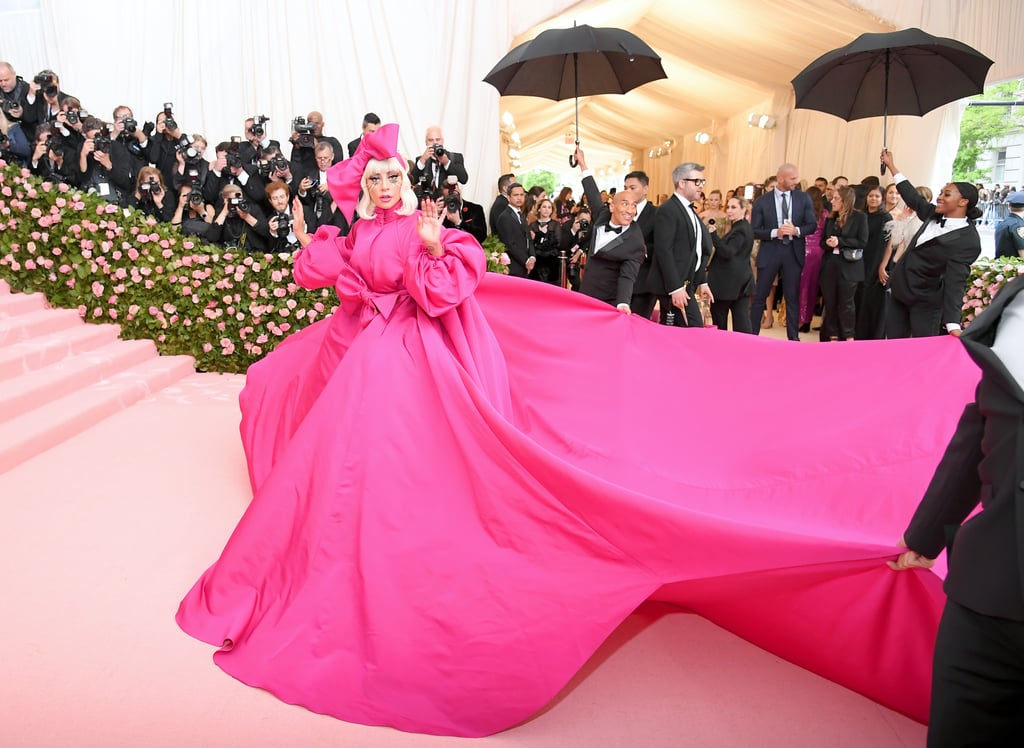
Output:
[953, 80, 1024, 182]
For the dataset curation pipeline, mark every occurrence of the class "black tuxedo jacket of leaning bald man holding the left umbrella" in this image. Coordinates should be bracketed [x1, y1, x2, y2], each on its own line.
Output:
[580, 176, 647, 305]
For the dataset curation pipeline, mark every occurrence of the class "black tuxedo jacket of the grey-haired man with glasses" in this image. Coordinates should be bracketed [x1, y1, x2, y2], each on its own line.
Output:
[643, 195, 712, 296]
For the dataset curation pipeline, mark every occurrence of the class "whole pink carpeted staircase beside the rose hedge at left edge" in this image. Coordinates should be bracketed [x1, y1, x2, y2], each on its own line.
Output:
[0, 281, 195, 473]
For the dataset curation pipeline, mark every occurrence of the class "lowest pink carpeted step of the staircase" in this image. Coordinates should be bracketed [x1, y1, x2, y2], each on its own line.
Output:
[0, 356, 195, 473]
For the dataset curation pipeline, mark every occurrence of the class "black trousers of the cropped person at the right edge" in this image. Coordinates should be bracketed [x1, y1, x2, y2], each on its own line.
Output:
[928, 600, 1024, 748]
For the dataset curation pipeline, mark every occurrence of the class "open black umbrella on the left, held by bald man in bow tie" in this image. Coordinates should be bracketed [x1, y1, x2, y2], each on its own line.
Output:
[483, 24, 668, 166]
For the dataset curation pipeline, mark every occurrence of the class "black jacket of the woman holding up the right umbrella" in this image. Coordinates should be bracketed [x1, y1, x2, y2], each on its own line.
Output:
[889, 179, 981, 325]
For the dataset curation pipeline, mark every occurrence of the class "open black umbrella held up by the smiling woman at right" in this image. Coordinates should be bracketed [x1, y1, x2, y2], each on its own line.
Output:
[793, 29, 992, 173]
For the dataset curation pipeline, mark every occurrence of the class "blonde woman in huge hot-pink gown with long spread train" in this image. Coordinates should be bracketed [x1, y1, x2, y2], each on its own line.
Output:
[177, 125, 977, 736]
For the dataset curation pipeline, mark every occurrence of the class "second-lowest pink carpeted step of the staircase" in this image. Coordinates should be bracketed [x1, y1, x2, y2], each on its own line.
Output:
[0, 340, 157, 422]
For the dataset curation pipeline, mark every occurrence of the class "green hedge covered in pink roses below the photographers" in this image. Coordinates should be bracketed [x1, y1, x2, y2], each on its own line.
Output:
[0, 162, 337, 372]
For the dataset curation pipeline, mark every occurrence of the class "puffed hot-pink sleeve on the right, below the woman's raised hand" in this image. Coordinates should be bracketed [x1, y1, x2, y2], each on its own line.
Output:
[406, 228, 487, 317]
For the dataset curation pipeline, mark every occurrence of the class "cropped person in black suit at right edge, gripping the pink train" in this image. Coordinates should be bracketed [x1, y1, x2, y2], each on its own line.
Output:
[889, 277, 1024, 746]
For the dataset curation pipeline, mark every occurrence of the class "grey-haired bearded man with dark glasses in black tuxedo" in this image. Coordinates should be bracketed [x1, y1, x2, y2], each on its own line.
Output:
[643, 162, 715, 327]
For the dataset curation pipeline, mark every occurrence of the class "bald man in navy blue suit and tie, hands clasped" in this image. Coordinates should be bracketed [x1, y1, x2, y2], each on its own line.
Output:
[751, 164, 818, 340]
